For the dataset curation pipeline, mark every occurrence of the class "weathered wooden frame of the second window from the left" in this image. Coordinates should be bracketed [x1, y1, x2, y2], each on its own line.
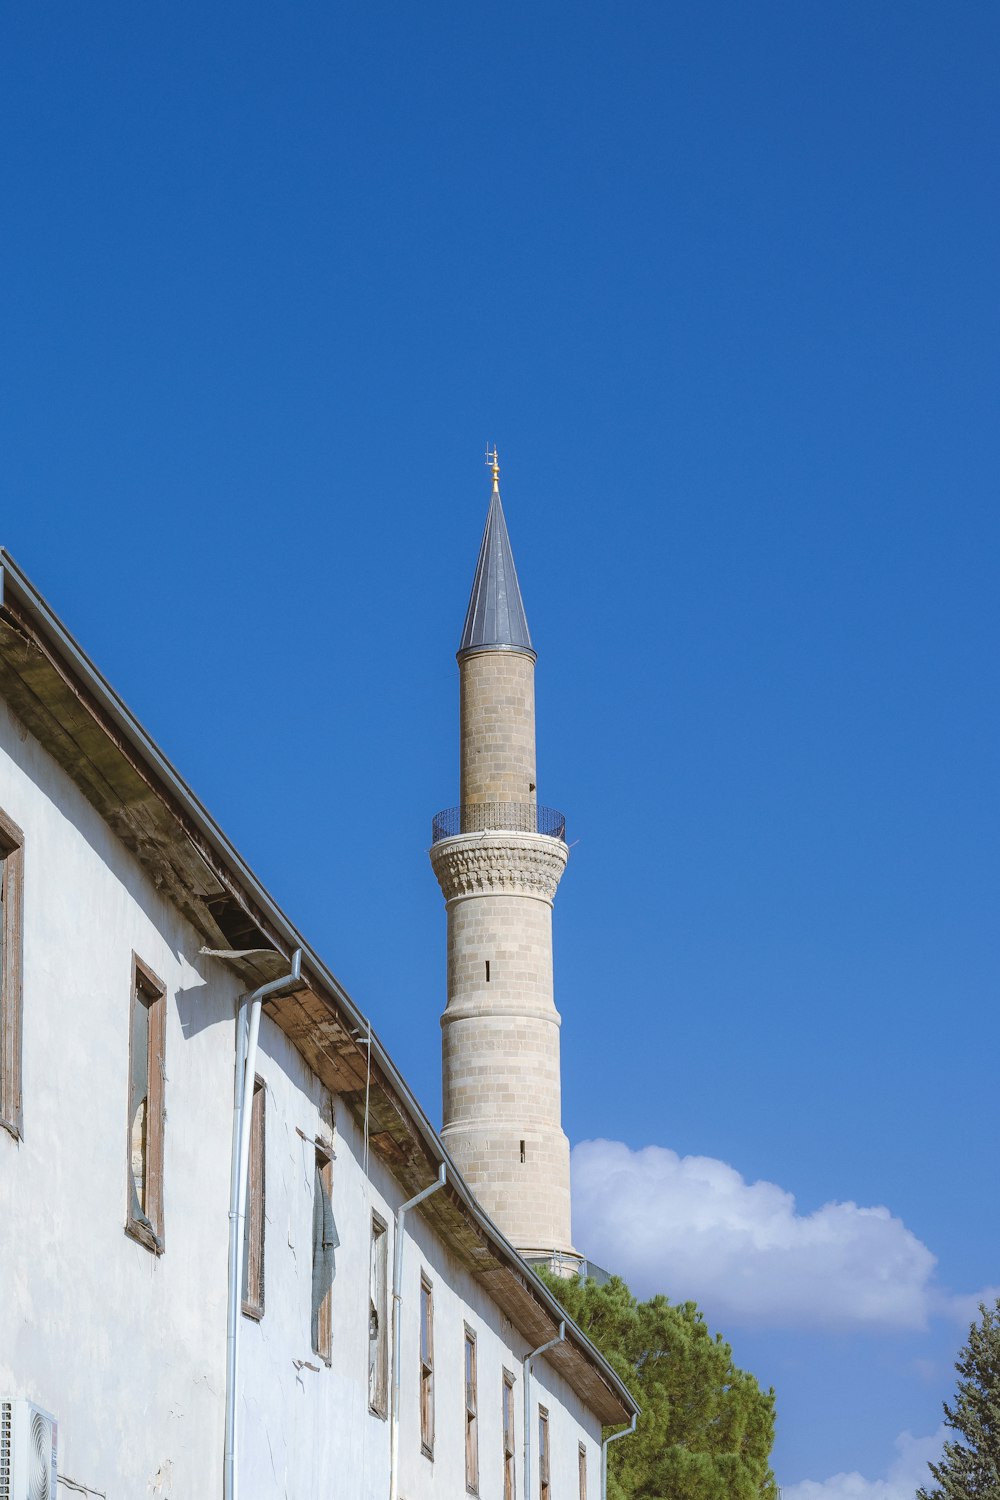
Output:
[124, 953, 166, 1256]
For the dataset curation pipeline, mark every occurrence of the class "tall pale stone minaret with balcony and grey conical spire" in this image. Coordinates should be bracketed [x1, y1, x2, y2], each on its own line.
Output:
[430, 450, 579, 1269]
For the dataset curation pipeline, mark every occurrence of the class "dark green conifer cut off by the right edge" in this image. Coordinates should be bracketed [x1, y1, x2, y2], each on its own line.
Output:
[916, 1298, 1000, 1500]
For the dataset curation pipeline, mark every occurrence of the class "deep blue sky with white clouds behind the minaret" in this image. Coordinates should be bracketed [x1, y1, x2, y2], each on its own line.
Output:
[0, 0, 1000, 1500]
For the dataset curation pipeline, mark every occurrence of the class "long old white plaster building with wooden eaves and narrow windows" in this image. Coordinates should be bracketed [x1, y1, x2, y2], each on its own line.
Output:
[0, 554, 636, 1500]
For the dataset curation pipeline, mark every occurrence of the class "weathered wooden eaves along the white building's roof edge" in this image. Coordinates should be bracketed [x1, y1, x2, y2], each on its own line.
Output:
[0, 549, 637, 1427]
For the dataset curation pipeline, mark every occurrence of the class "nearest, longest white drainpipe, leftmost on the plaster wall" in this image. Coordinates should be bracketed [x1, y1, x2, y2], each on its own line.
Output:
[223, 948, 301, 1500]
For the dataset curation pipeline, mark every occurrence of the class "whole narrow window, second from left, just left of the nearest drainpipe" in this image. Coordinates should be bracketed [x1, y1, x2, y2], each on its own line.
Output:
[124, 954, 166, 1256]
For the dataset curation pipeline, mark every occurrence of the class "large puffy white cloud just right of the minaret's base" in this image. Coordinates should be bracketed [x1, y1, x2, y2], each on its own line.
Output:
[573, 1140, 940, 1332]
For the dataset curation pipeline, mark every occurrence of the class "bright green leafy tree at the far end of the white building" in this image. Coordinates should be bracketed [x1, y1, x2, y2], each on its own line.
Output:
[543, 1274, 778, 1500]
